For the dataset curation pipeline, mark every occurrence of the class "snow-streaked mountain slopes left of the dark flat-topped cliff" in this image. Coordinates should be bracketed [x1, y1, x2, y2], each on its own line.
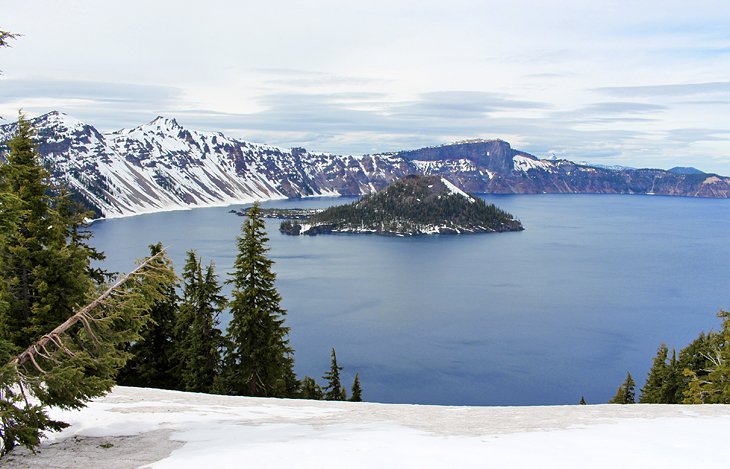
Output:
[0, 111, 409, 217]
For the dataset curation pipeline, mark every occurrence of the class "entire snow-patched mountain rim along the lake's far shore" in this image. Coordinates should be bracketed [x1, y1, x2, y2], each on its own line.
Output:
[0, 111, 730, 217]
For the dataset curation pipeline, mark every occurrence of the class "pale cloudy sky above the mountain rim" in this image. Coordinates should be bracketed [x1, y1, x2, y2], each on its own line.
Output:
[0, 0, 730, 174]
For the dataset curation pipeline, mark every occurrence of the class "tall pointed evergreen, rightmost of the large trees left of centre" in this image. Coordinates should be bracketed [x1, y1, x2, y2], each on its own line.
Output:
[222, 203, 298, 397]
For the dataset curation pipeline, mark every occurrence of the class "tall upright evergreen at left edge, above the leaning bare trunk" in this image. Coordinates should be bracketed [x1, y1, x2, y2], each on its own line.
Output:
[0, 114, 104, 348]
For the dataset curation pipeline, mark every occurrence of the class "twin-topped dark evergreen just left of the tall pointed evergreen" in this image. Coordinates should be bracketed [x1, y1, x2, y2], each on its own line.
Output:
[174, 251, 226, 392]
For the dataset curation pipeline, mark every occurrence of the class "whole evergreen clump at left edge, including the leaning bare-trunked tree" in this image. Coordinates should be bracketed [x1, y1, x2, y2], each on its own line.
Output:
[0, 111, 155, 453]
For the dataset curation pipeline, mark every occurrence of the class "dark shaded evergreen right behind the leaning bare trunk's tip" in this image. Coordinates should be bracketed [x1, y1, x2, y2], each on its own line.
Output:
[117, 243, 179, 389]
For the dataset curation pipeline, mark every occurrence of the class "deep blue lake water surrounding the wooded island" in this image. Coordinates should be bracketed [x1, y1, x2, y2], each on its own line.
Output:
[92, 195, 730, 405]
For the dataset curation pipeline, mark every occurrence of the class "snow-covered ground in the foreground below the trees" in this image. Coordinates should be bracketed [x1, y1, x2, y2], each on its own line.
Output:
[2, 387, 730, 469]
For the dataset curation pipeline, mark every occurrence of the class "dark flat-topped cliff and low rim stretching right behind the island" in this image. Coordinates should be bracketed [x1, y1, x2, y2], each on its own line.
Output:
[396, 140, 730, 198]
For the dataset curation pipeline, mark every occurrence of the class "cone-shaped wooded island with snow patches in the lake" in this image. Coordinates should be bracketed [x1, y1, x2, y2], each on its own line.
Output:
[280, 175, 523, 236]
